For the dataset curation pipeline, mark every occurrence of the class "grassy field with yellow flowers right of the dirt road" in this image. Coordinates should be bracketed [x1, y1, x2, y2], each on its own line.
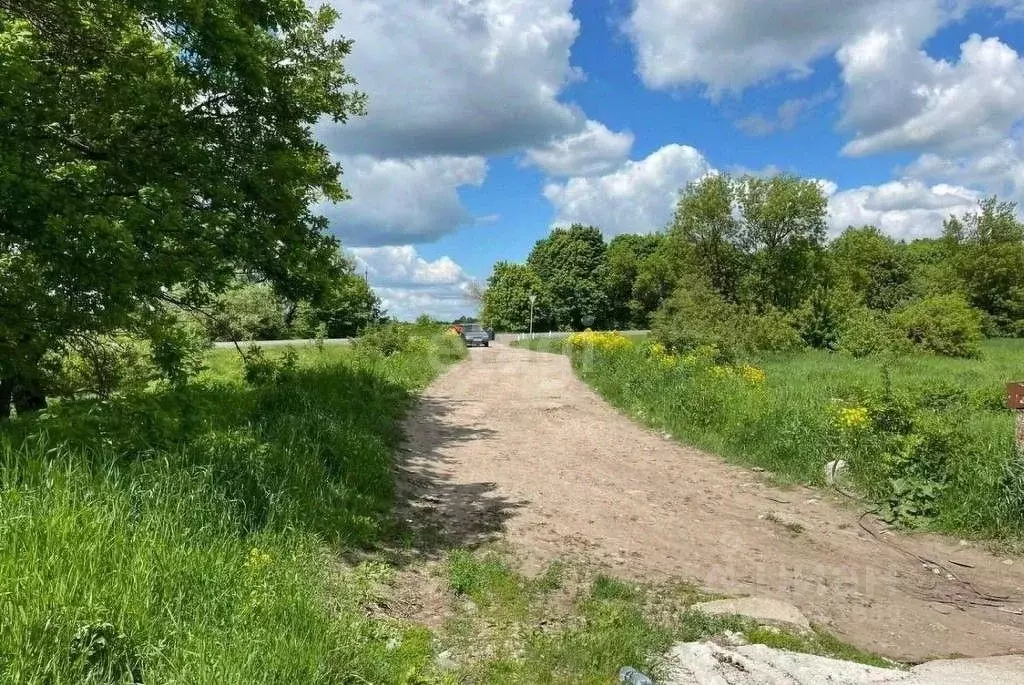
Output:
[520, 336, 1024, 539]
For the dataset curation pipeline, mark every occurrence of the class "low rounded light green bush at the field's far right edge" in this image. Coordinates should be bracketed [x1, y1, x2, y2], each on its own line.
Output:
[893, 295, 982, 358]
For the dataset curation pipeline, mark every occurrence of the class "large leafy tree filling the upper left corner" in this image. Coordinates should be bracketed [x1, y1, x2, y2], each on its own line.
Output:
[0, 0, 364, 413]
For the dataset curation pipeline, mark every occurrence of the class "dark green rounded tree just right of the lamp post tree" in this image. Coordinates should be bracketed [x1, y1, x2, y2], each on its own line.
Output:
[526, 224, 607, 330]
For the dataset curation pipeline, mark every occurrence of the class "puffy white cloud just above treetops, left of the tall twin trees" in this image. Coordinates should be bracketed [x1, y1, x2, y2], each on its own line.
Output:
[544, 144, 712, 236]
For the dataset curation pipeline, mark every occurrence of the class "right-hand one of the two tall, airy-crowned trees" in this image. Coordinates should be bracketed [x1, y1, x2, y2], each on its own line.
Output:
[736, 175, 828, 310]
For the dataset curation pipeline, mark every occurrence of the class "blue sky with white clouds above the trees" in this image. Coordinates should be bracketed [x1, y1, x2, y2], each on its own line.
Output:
[317, 0, 1024, 317]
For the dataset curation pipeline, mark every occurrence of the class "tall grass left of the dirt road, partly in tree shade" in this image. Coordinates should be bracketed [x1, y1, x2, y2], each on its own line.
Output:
[0, 340, 464, 685]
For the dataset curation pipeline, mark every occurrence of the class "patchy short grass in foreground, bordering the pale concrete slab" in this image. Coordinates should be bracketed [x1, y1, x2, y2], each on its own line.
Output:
[442, 552, 898, 684]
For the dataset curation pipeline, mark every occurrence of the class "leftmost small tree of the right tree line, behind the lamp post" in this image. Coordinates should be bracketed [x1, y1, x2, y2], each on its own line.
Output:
[480, 261, 547, 333]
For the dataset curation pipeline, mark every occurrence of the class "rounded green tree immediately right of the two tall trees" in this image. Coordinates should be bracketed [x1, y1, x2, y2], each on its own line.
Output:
[828, 226, 911, 310]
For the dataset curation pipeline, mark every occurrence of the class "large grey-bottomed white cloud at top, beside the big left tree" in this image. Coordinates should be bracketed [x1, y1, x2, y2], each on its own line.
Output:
[318, 0, 585, 157]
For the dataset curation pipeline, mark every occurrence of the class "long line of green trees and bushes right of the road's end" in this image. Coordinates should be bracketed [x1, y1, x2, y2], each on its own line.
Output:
[480, 175, 1024, 356]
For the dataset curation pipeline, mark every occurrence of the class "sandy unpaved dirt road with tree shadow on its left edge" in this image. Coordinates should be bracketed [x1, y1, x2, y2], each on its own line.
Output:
[398, 345, 1024, 662]
